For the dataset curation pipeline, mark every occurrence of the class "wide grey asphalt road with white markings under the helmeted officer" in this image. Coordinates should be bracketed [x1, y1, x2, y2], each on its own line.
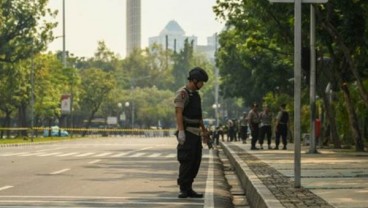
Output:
[0, 137, 230, 207]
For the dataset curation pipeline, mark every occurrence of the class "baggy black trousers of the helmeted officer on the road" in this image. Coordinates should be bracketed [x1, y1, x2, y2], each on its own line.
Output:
[177, 131, 202, 191]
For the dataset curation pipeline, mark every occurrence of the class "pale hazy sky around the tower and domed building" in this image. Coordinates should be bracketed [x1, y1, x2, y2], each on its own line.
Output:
[49, 0, 224, 57]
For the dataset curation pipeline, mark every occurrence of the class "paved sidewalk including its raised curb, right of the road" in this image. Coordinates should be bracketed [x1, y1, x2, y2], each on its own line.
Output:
[221, 142, 368, 208]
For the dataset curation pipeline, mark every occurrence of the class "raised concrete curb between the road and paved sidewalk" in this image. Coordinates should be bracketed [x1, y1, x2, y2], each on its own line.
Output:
[221, 142, 284, 208]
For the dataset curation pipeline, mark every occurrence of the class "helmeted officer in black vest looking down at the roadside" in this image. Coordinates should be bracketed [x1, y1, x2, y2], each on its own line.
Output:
[174, 67, 208, 198]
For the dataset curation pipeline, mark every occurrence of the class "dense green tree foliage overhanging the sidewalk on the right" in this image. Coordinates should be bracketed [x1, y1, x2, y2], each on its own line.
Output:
[214, 0, 368, 151]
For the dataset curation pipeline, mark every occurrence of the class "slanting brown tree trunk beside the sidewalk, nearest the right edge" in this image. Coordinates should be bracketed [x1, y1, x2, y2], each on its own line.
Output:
[341, 83, 364, 152]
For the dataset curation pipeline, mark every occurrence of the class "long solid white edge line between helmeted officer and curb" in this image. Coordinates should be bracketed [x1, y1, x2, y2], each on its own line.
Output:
[203, 150, 215, 208]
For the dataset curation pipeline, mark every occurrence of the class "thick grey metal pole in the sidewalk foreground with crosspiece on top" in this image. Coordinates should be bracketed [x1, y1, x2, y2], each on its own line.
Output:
[269, 0, 328, 188]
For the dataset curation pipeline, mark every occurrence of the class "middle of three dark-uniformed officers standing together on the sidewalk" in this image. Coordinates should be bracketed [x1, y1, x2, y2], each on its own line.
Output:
[259, 105, 272, 149]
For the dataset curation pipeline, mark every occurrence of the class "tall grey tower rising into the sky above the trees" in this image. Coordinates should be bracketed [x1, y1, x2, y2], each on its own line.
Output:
[126, 0, 141, 56]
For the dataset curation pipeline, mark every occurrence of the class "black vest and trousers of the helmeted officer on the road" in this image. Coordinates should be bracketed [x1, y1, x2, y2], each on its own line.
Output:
[177, 90, 202, 195]
